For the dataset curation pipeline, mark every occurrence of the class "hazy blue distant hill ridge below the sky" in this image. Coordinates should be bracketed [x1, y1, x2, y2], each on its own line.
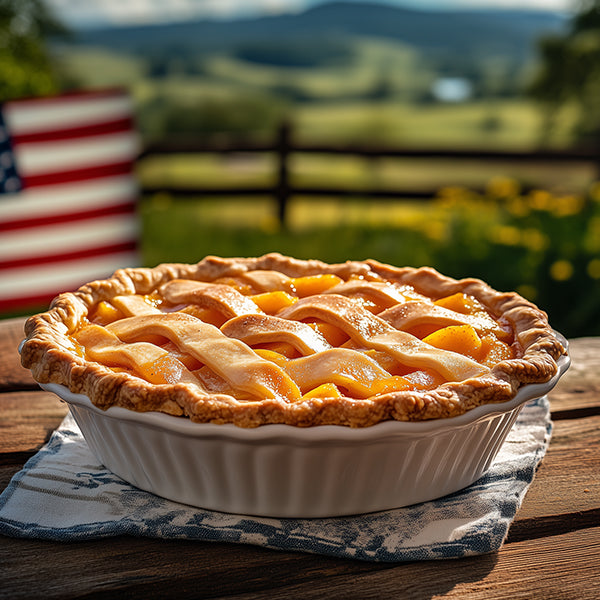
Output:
[71, 2, 565, 59]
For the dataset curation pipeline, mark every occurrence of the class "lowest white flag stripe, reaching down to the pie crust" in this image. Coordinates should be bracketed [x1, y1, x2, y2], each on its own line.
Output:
[0, 252, 137, 300]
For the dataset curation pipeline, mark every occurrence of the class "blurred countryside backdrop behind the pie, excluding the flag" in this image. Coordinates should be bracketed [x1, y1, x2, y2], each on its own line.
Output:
[0, 0, 600, 336]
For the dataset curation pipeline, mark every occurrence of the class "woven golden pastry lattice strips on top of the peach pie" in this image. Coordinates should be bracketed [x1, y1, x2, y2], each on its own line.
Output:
[84, 272, 502, 401]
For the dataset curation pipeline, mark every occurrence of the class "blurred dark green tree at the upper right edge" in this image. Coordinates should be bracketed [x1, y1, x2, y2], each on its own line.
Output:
[530, 0, 600, 144]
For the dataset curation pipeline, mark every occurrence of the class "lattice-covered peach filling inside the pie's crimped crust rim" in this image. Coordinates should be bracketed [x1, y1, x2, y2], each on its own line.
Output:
[72, 271, 515, 402]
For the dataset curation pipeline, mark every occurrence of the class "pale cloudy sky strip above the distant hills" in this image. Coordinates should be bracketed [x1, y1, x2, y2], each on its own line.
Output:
[46, 0, 575, 26]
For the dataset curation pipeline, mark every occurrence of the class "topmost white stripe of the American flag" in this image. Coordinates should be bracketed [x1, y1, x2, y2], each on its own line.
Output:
[3, 95, 132, 135]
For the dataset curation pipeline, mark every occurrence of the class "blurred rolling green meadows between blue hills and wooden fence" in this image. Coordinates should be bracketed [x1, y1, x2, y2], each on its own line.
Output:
[57, 37, 574, 149]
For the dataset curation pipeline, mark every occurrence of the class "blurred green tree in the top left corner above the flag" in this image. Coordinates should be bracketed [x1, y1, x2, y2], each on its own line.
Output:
[0, 0, 68, 101]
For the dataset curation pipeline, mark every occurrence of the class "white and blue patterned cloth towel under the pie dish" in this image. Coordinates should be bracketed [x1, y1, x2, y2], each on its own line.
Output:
[0, 397, 552, 562]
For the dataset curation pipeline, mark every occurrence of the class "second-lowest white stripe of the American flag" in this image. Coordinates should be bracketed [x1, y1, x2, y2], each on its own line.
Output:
[0, 215, 138, 260]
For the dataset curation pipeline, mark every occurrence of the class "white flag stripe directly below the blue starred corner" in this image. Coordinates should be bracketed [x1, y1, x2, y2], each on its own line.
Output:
[0, 175, 139, 223]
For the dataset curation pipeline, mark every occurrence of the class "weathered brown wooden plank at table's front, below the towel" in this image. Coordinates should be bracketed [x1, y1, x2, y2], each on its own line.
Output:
[0, 527, 600, 600]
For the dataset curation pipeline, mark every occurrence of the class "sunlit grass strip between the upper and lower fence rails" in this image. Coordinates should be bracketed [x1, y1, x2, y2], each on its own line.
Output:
[138, 145, 596, 199]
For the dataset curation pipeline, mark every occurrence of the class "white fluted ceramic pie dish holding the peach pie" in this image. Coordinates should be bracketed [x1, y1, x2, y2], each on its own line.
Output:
[40, 337, 570, 518]
